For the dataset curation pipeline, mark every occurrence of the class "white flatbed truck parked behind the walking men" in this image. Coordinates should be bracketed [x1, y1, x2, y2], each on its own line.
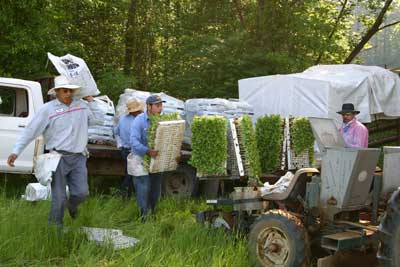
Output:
[0, 77, 197, 195]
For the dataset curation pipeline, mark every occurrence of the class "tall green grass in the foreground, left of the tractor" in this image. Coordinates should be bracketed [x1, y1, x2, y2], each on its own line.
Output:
[0, 176, 251, 267]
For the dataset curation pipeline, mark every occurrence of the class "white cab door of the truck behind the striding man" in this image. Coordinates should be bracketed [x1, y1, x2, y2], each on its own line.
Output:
[0, 83, 35, 173]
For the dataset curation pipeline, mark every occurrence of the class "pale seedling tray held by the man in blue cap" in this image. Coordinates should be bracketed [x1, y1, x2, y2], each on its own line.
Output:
[149, 120, 185, 173]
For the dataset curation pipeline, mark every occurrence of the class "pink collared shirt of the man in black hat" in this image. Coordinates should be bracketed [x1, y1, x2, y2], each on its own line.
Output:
[339, 119, 368, 148]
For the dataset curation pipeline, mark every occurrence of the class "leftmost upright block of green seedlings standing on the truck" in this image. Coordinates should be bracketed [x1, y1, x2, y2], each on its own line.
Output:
[189, 116, 228, 176]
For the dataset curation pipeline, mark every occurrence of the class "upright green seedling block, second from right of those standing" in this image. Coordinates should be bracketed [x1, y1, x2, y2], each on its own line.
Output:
[256, 115, 284, 173]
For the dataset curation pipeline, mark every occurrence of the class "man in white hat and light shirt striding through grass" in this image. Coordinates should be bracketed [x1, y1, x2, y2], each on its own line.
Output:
[8, 76, 102, 227]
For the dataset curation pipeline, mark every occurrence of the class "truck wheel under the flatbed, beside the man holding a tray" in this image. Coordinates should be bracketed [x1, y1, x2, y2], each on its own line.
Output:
[163, 164, 198, 197]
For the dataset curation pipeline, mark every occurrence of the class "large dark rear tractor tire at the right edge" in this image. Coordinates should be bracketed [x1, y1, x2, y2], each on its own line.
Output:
[378, 191, 400, 267]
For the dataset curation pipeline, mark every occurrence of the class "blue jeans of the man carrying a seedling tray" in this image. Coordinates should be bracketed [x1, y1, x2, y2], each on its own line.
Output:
[133, 173, 162, 217]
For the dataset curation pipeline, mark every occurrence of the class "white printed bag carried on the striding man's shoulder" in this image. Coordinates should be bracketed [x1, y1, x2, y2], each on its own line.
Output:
[47, 52, 100, 98]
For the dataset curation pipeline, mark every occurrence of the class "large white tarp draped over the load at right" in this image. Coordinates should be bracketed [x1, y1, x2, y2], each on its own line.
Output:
[239, 64, 400, 122]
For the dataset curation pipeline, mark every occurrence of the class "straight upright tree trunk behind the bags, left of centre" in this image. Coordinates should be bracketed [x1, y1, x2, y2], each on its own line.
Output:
[124, 0, 136, 75]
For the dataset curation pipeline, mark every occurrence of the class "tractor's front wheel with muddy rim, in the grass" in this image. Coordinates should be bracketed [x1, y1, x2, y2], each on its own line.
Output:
[249, 210, 310, 267]
